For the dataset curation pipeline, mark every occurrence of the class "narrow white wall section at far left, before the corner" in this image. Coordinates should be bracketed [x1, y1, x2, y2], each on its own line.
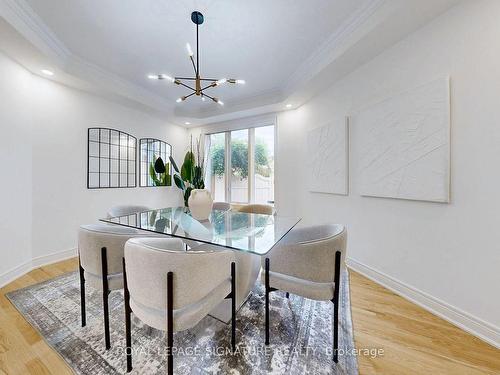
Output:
[0, 50, 32, 285]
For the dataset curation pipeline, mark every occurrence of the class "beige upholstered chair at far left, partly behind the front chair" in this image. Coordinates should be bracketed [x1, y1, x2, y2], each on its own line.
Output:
[78, 224, 157, 349]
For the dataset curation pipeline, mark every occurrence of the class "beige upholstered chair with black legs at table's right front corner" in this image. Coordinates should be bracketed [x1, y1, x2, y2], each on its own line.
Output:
[262, 224, 347, 362]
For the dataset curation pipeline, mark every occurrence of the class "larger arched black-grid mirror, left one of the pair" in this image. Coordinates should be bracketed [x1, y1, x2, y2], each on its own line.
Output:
[87, 128, 137, 189]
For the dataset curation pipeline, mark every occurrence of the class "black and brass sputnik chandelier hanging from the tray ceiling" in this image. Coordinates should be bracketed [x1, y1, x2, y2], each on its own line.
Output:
[148, 11, 245, 105]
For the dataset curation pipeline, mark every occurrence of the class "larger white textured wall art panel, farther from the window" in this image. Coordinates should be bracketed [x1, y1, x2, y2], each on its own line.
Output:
[354, 78, 450, 202]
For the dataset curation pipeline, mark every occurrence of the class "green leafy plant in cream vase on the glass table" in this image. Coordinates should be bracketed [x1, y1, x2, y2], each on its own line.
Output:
[170, 138, 213, 220]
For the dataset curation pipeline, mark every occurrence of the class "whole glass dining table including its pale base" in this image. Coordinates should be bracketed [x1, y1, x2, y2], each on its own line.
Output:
[101, 207, 300, 323]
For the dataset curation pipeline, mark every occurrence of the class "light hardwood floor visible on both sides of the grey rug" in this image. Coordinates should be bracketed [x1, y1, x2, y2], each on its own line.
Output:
[0, 259, 500, 375]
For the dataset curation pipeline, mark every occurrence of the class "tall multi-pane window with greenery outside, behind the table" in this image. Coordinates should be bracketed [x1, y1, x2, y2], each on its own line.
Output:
[206, 126, 274, 204]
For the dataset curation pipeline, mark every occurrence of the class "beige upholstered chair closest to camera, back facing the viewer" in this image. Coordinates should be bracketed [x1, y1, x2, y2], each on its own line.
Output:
[123, 238, 236, 374]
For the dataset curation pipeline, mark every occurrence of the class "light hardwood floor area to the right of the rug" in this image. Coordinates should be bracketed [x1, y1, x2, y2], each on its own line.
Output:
[351, 271, 500, 374]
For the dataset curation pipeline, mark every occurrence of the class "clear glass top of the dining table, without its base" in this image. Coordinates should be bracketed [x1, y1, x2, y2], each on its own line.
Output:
[101, 207, 300, 255]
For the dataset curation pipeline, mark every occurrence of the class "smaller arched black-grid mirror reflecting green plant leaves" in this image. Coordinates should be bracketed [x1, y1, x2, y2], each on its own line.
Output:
[139, 138, 172, 186]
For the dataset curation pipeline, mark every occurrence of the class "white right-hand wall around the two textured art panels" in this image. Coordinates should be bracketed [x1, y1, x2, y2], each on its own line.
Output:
[276, 0, 500, 346]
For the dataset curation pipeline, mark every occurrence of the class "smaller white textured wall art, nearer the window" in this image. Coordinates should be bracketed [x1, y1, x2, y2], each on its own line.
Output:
[307, 117, 349, 195]
